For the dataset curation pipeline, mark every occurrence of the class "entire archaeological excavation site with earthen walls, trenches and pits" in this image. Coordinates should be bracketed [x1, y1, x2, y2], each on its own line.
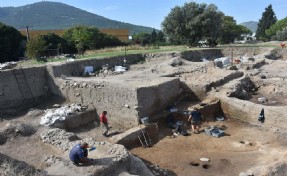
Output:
[0, 46, 287, 176]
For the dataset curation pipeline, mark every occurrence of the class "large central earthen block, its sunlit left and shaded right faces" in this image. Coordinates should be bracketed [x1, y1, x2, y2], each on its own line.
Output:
[49, 78, 180, 128]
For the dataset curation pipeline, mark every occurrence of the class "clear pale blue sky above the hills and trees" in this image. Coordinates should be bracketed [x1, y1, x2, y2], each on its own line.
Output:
[0, 0, 287, 29]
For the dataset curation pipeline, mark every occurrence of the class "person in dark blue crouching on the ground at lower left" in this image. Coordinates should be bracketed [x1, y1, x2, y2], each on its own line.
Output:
[69, 142, 92, 165]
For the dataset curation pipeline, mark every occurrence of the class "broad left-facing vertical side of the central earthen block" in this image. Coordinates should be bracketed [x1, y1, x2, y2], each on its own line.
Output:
[53, 80, 138, 127]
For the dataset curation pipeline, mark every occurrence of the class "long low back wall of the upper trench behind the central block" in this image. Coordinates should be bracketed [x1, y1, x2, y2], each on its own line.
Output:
[51, 54, 144, 77]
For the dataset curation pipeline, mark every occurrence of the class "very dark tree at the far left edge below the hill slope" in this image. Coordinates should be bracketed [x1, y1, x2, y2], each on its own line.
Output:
[0, 22, 25, 62]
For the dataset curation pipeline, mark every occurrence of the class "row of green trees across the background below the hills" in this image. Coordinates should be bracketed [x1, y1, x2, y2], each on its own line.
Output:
[0, 2, 287, 62]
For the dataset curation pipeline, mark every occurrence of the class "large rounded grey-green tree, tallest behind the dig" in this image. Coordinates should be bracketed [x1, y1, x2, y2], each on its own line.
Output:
[161, 2, 224, 45]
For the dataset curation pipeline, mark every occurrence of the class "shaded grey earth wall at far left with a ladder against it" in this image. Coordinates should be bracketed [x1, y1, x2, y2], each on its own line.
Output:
[0, 67, 50, 109]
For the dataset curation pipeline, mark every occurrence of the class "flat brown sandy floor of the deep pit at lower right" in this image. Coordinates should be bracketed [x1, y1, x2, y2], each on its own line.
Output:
[131, 116, 287, 176]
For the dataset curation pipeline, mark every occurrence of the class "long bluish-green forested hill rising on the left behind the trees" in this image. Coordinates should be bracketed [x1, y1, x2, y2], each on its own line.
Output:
[0, 1, 156, 34]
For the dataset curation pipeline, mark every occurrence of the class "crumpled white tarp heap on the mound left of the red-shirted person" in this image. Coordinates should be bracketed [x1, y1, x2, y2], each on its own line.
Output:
[40, 104, 82, 126]
